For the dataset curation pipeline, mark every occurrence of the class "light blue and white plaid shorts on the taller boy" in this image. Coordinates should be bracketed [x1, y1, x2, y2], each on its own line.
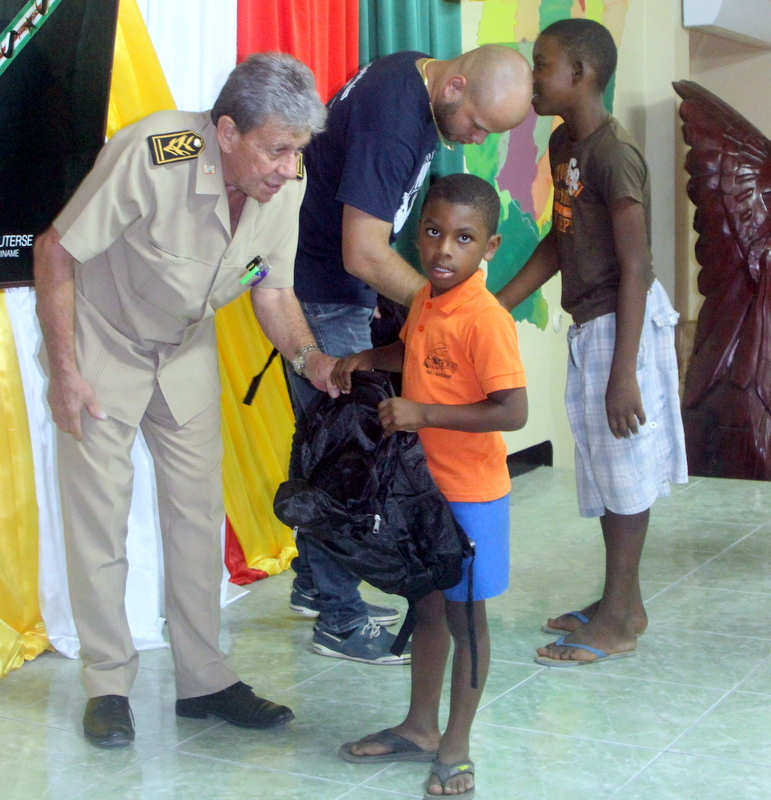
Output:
[565, 281, 688, 517]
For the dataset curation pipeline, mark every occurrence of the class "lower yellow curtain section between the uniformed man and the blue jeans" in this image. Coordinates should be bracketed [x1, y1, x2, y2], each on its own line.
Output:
[216, 292, 297, 575]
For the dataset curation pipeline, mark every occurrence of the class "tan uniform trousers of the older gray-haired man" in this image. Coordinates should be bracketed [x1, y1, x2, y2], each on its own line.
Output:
[58, 382, 238, 698]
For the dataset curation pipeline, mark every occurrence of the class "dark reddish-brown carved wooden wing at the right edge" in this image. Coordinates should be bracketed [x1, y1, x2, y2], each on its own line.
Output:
[673, 81, 771, 407]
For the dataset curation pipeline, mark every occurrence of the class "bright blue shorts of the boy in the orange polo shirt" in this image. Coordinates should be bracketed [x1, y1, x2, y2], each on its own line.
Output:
[444, 494, 509, 603]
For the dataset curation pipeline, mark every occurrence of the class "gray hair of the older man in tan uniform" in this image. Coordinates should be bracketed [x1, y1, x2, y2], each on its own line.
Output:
[211, 53, 327, 134]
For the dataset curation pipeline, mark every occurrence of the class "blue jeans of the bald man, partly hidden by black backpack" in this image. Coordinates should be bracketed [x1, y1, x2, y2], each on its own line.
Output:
[286, 302, 373, 633]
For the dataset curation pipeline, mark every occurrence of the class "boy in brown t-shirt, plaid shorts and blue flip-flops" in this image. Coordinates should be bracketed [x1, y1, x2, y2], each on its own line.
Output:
[498, 19, 687, 667]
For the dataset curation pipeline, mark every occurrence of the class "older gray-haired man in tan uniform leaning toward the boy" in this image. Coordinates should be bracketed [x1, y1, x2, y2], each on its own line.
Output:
[35, 54, 335, 747]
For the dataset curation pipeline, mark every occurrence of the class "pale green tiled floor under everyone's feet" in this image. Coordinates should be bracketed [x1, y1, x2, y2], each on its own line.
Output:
[0, 468, 771, 800]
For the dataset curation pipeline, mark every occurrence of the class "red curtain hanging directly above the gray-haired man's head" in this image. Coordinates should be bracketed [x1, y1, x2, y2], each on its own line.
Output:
[237, 0, 359, 103]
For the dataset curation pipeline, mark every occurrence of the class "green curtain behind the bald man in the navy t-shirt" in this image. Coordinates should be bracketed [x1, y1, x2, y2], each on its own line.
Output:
[359, 0, 463, 268]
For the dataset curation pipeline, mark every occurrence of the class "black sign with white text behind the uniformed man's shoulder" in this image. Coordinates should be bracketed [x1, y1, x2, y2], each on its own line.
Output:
[0, 0, 118, 286]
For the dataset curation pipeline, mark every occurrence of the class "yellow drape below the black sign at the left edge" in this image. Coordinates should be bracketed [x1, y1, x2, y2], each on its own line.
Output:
[0, 291, 51, 677]
